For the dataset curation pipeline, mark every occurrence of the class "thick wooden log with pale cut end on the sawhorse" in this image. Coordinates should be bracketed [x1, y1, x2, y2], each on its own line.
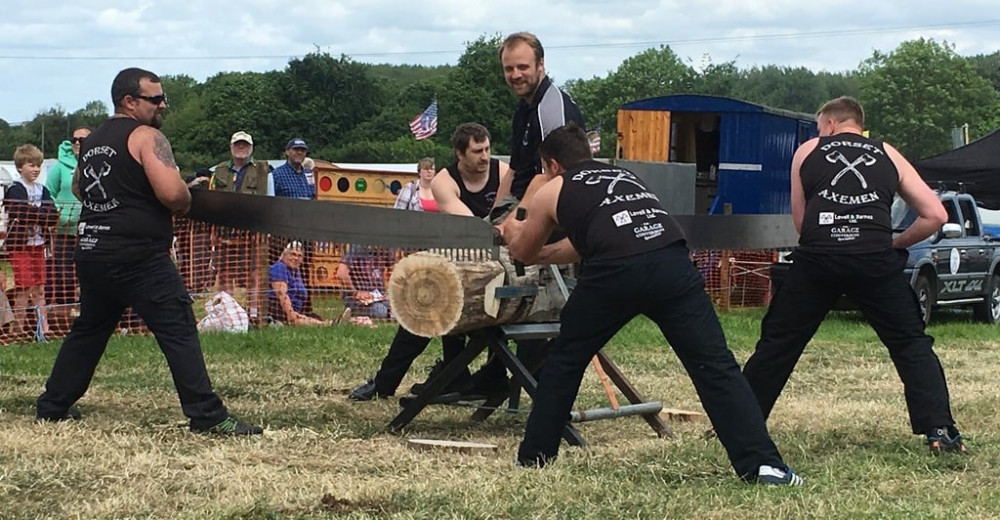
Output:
[388, 251, 565, 337]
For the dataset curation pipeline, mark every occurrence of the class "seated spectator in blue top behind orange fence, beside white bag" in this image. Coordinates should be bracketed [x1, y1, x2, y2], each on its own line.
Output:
[267, 241, 329, 325]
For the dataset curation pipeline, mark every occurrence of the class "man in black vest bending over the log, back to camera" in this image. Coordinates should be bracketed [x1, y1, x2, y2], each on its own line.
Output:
[498, 125, 803, 485]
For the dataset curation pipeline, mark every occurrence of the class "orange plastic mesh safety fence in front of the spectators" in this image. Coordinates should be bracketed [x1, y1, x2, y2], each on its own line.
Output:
[0, 200, 775, 344]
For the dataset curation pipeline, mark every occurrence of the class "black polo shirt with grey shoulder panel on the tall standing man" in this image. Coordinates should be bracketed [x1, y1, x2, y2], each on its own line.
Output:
[510, 76, 584, 200]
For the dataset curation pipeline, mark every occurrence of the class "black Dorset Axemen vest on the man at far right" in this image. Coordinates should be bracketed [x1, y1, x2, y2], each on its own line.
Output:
[799, 133, 899, 254]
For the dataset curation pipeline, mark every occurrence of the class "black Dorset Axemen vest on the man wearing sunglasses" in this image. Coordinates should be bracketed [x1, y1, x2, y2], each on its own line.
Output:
[76, 117, 172, 262]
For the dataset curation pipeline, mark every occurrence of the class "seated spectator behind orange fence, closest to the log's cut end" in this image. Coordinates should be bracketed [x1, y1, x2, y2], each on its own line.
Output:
[337, 246, 392, 319]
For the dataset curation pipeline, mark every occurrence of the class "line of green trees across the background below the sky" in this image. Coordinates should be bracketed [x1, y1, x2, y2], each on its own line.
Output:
[0, 35, 1000, 171]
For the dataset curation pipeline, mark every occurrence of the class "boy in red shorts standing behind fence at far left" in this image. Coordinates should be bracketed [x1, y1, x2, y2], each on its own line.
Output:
[4, 144, 59, 335]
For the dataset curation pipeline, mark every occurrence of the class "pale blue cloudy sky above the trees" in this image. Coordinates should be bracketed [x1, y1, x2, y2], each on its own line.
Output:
[0, 0, 1000, 123]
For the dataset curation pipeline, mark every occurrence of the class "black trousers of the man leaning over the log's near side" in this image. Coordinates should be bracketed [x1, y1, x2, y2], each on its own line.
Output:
[518, 244, 785, 479]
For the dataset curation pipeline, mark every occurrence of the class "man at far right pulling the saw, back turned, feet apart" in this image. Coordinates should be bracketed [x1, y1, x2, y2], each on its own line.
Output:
[743, 97, 965, 453]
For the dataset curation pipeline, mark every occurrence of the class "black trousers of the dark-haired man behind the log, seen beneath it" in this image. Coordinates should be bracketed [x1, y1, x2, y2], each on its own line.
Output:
[375, 327, 507, 395]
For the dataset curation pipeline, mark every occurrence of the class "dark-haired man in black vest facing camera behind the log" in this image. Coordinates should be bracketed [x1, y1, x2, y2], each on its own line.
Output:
[348, 123, 509, 401]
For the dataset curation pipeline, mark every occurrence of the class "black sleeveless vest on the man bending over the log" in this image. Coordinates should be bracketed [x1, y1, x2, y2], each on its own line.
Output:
[556, 161, 684, 260]
